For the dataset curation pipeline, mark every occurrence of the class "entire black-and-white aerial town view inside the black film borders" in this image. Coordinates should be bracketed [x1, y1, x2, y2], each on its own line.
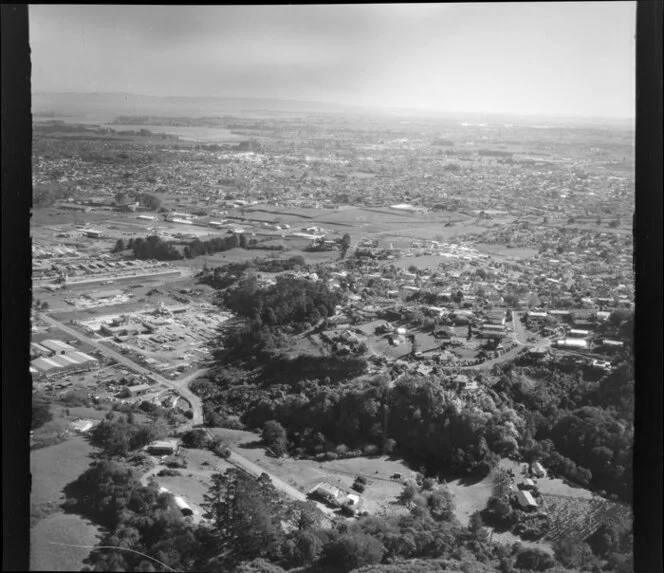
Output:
[20, 2, 636, 573]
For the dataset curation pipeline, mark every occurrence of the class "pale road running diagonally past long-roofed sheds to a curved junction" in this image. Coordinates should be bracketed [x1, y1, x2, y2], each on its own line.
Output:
[37, 313, 207, 426]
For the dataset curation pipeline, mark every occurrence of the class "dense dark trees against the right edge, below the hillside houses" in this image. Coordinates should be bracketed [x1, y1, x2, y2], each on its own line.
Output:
[493, 361, 634, 501]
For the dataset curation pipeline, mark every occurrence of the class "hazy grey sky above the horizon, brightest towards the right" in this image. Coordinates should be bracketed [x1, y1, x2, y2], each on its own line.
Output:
[29, 2, 636, 118]
